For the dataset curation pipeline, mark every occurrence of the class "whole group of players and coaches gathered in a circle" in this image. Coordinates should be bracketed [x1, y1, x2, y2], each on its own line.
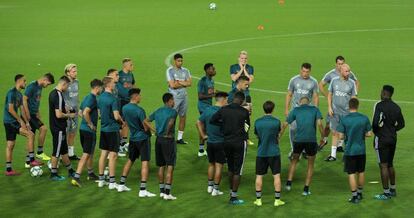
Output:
[3, 51, 404, 206]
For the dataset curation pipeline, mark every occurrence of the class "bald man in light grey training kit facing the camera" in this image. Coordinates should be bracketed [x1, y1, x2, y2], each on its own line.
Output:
[325, 64, 357, 162]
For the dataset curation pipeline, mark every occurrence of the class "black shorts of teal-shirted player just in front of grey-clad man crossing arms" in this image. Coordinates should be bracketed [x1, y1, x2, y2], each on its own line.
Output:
[155, 137, 177, 167]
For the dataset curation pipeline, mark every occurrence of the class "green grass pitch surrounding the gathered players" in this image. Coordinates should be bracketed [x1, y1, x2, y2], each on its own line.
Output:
[0, 0, 414, 217]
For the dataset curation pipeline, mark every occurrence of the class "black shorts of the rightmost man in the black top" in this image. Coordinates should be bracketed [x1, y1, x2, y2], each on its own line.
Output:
[374, 137, 397, 167]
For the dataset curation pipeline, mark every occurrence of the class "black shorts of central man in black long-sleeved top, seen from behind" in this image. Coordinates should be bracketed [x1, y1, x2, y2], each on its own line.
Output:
[224, 141, 247, 175]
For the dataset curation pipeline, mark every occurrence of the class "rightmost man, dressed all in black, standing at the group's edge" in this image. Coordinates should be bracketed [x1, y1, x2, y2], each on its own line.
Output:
[372, 85, 405, 200]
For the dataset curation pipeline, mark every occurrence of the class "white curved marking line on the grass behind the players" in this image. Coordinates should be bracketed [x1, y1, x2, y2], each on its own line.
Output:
[164, 27, 414, 104]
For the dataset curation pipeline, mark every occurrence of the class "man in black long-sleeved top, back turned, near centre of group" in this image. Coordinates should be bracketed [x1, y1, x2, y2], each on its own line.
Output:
[210, 92, 250, 205]
